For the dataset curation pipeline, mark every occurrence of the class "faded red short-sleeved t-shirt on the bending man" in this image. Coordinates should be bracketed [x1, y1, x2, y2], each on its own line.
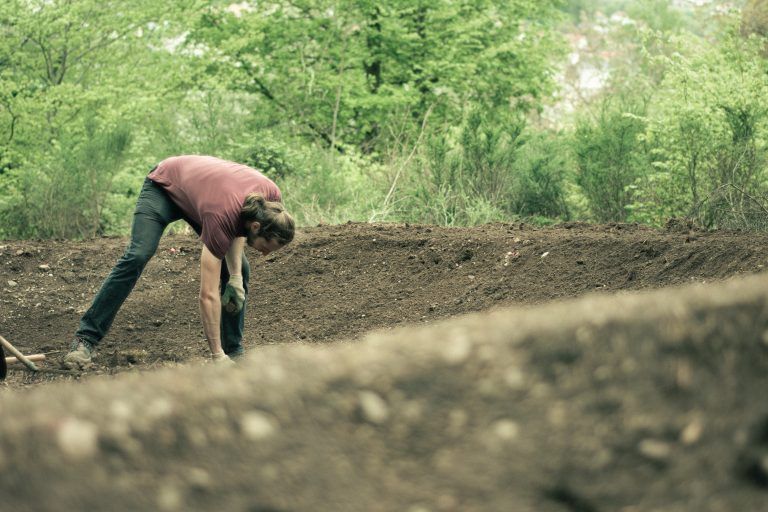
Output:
[149, 155, 282, 259]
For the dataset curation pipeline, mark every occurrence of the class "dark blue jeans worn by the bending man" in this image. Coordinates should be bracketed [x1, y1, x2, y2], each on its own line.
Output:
[75, 178, 251, 355]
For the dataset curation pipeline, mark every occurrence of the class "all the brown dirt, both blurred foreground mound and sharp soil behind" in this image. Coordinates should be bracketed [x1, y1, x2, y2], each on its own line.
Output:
[0, 224, 768, 512]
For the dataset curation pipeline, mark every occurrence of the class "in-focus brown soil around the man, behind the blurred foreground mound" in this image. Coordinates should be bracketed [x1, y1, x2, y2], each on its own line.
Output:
[0, 223, 768, 392]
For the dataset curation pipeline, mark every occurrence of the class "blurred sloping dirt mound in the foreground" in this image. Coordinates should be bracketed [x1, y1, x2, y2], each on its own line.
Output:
[0, 275, 768, 512]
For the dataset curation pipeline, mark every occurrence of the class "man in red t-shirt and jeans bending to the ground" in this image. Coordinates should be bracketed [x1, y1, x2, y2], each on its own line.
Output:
[64, 155, 294, 369]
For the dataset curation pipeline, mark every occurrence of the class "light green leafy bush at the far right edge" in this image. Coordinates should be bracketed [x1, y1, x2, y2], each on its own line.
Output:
[632, 27, 768, 226]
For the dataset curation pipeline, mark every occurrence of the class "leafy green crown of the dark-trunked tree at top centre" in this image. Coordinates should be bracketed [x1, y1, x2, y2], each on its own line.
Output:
[191, 0, 559, 153]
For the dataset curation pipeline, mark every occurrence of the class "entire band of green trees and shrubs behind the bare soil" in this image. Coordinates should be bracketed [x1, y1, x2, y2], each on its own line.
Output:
[0, 0, 768, 238]
